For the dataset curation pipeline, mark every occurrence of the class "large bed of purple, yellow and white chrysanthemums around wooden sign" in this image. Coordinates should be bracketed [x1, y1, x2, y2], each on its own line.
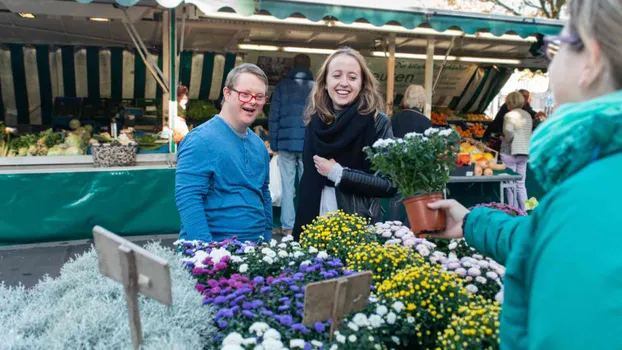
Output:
[177, 212, 504, 350]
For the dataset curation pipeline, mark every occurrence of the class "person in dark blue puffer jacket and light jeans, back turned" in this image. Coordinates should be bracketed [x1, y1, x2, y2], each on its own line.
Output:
[269, 54, 315, 235]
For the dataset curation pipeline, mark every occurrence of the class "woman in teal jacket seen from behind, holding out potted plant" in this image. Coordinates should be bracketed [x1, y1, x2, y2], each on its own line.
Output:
[430, 0, 622, 350]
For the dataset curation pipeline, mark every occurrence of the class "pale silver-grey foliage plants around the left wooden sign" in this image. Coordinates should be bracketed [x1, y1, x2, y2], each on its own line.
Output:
[0, 243, 216, 350]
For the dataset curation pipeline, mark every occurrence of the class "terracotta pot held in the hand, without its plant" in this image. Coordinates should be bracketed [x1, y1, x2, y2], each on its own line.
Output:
[402, 193, 445, 235]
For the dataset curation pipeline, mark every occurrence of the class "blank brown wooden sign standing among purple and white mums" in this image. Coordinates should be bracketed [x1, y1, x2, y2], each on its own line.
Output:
[302, 271, 372, 341]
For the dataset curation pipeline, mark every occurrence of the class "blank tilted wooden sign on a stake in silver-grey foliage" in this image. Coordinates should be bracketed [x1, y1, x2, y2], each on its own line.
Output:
[93, 226, 173, 349]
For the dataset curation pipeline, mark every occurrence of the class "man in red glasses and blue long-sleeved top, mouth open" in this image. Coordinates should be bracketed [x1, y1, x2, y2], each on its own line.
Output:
[175, 64, 272, 242]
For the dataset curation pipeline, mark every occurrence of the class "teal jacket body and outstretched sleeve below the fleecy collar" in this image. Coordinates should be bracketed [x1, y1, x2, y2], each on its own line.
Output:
[464, 153, 622, 350]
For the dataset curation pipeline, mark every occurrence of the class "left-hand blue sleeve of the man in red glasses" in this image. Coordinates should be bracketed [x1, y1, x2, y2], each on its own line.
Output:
[175, 132, 216, 242]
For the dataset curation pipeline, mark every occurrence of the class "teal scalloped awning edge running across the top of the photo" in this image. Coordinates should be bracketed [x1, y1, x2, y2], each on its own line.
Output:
[76, 0, 564, 38]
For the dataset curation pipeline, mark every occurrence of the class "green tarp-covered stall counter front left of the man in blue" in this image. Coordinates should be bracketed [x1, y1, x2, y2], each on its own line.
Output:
[0, 154, 180, 245]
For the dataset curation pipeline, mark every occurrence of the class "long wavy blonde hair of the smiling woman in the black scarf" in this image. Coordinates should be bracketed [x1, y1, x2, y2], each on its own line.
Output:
[305, 47, 384, 124]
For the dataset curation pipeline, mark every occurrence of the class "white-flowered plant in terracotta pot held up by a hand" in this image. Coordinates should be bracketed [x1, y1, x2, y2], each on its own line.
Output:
[365, 128, 460, 234]
